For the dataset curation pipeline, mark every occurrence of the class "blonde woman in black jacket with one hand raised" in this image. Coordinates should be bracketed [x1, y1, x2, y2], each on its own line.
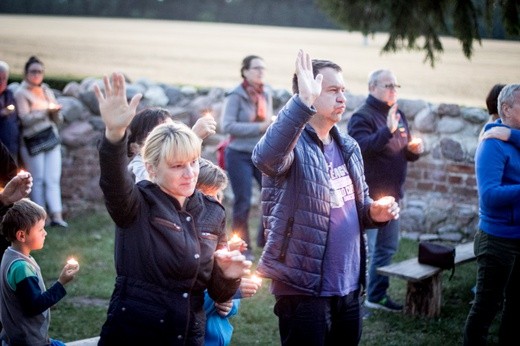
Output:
[95, 74, 251, 345]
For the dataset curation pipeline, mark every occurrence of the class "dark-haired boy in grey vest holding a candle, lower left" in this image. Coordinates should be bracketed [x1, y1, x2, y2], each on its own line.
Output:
[0, 198, 79, 346]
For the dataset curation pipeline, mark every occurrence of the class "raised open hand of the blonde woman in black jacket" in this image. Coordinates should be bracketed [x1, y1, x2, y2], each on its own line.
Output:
[94, 73, 142, 143]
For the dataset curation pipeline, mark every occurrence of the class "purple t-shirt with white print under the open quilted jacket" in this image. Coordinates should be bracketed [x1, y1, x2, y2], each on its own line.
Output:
[321, 141, 361, 296]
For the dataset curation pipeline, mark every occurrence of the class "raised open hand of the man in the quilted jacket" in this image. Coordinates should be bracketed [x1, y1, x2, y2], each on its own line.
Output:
[296, 49, 323, 107]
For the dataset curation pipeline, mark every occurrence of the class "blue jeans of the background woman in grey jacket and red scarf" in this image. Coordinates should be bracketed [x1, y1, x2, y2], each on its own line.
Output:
[225, 147, 263, 249]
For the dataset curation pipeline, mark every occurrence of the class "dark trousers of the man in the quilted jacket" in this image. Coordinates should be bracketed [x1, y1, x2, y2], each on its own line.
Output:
[274, 290, 362, 346]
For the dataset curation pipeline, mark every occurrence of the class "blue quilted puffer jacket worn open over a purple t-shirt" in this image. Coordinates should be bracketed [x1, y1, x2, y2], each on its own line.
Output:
[252, 95, 378, 296]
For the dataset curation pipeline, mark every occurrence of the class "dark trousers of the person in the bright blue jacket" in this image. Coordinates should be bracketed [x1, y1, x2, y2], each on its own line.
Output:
[464, 230, 520, 345]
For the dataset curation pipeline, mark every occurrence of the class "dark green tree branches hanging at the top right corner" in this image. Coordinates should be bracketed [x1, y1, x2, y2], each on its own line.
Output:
[317, 0, 520, 67]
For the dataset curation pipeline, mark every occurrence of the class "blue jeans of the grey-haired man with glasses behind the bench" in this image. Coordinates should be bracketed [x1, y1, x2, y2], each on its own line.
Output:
[366, 220, 399, 302]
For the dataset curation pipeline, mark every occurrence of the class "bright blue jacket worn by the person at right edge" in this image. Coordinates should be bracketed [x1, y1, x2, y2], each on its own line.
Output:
[475, 119, 520, 239]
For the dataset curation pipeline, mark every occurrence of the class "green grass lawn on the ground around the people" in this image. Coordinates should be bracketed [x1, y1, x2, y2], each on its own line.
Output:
[33, 207, 498, 346]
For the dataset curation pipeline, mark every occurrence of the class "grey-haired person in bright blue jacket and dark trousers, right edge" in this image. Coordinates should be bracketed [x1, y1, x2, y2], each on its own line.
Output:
[464, 84, 520, 345]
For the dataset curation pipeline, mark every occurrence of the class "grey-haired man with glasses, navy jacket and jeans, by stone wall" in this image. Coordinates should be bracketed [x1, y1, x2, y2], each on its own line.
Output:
[347, 69, 423, 312]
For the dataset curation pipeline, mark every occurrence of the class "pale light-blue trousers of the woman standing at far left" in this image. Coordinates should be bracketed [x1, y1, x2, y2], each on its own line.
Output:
[20, 145, 62, 217]
